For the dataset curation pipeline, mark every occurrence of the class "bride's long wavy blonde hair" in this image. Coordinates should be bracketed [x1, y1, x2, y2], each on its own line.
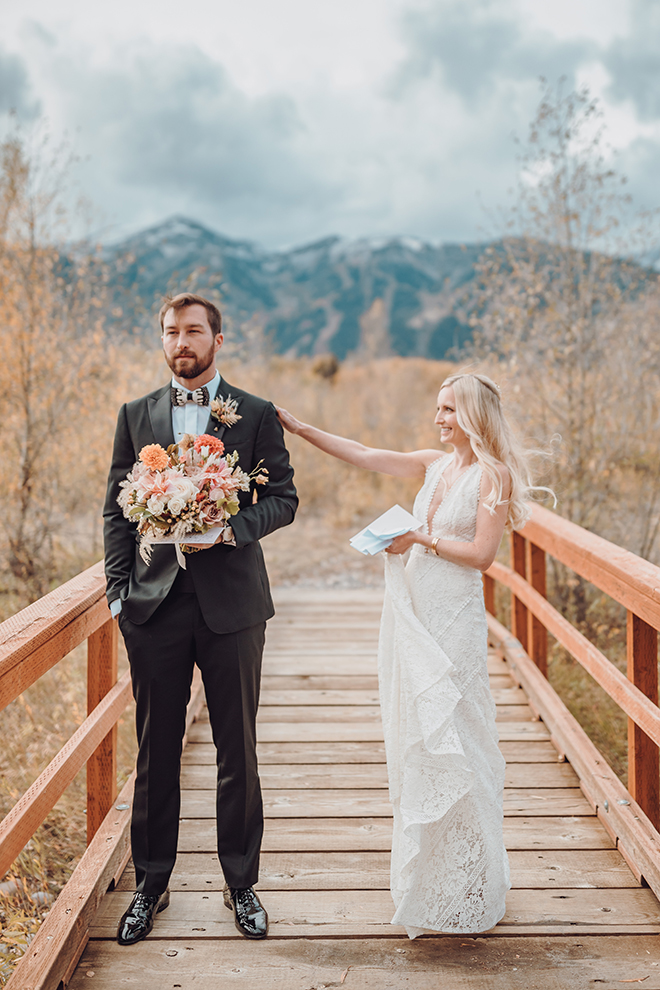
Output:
[440, 372, 553, 529]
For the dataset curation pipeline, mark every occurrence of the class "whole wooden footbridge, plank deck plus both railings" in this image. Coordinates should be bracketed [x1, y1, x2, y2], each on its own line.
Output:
[0, 508, 660, 990]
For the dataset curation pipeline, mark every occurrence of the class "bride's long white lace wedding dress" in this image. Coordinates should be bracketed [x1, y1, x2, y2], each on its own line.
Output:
[378, 455, 510, 938]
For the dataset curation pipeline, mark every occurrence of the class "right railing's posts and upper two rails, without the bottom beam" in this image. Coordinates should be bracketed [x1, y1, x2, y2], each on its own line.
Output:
[484, 506, 660, 841]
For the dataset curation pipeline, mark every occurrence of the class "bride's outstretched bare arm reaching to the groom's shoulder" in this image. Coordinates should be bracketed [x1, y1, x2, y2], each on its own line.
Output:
[277, 407, 439, 478]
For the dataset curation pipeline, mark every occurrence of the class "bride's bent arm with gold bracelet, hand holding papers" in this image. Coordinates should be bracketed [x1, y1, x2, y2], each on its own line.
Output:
[386, 465, 511, 571]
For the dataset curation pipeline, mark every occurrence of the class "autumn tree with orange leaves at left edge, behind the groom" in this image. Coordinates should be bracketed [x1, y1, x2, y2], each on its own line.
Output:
[0, 134, 130, 612]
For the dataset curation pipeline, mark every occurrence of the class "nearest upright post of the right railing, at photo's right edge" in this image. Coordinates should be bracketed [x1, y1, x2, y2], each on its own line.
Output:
[627, 611, 660, 828]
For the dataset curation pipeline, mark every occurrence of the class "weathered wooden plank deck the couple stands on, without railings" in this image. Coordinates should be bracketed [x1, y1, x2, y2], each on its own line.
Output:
[69, 589, 660, 990]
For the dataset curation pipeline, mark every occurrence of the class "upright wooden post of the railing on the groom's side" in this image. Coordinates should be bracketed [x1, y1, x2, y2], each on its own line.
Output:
[87, 619, 117, 845]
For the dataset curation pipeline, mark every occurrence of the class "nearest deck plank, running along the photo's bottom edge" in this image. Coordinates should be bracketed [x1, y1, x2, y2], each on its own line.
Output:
[64, 934, 660, 990]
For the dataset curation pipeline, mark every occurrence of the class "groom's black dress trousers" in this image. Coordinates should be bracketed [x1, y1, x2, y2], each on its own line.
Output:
[120, 579, 266, 894]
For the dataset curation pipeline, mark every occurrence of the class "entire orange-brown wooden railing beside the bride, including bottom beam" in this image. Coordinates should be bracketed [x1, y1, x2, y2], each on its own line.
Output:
[484, 506, 660, 896]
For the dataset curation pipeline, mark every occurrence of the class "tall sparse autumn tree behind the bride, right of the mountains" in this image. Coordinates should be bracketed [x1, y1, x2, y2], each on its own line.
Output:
[472, 84, 660, 556]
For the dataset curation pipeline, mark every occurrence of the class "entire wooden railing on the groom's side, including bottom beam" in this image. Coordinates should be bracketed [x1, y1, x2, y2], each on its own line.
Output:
[0, 563, 203, 990]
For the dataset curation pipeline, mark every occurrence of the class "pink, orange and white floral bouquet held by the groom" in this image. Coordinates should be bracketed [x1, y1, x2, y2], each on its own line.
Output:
[117, 433, 268, 564]
